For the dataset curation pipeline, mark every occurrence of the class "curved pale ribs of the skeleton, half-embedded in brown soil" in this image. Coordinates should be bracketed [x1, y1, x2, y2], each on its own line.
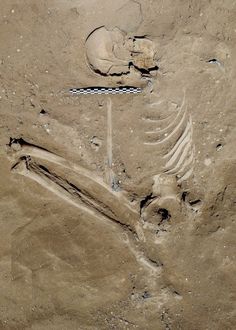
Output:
[142, 93, 194, 183]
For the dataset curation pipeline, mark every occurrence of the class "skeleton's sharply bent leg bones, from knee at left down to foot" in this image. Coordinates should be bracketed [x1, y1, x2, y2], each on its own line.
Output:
[9, 139, 166, 276]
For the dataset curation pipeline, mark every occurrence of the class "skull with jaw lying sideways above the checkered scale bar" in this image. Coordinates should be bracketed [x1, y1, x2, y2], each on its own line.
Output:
[85, 27, 156, 76]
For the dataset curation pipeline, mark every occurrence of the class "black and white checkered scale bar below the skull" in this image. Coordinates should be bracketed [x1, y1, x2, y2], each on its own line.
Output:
[69, 86, 142, 95]
